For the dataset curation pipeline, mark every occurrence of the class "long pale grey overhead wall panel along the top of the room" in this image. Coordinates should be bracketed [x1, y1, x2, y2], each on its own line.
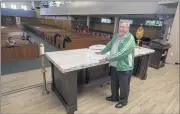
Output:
[40, 0, 176, 15]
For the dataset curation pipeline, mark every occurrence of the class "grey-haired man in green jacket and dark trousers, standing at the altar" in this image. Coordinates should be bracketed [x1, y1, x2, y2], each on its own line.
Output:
[99, 20, 135, 108]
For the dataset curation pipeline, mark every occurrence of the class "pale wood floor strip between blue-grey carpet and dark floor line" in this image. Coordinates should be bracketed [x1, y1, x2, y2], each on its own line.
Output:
[1, 67, 51, 95]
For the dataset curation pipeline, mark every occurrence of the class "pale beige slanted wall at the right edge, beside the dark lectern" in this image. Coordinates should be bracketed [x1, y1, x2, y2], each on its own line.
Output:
[166, 3, 180, 64]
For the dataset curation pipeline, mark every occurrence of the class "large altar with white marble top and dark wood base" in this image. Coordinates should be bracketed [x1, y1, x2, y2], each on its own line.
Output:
[45, 47, 154, 113]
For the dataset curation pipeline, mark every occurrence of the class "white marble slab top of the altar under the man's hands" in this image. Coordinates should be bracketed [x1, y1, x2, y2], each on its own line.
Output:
[45, 47, 154, 73]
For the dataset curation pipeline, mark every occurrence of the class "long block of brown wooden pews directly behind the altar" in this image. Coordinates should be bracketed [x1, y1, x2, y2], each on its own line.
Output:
[23, 24, 110, 50]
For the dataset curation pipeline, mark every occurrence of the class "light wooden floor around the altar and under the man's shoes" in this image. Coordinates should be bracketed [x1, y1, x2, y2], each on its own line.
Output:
[1, 64, 179, 114]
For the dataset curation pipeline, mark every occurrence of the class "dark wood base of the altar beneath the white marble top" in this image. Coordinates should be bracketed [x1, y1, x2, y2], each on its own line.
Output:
[50, 55, 149, 114]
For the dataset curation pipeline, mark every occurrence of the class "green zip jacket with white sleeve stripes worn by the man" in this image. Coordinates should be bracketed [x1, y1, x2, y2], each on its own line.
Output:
[101, 32, 136, 71]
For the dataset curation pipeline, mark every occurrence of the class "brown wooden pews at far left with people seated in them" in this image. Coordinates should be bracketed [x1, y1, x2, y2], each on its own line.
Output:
[1, 26, 39, 62]
